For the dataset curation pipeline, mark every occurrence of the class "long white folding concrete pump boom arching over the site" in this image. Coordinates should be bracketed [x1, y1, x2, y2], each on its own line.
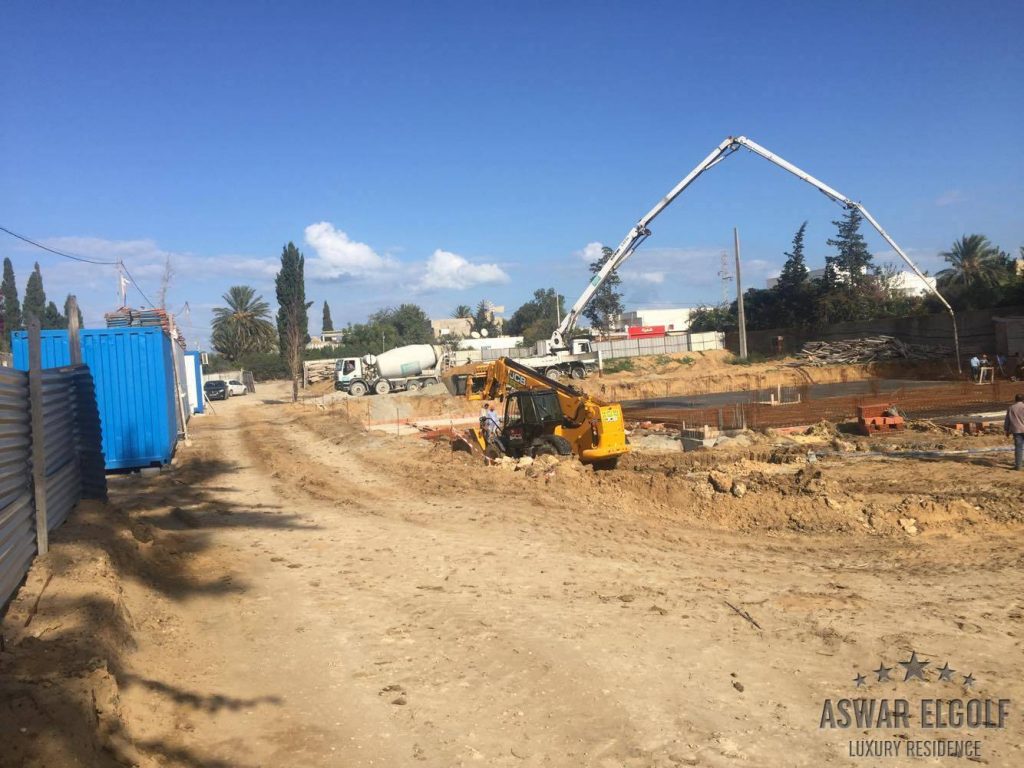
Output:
[551, 136, 962, 371]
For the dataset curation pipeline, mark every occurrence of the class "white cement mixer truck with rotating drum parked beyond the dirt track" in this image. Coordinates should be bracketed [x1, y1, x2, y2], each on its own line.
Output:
[334, 344, 445, 397]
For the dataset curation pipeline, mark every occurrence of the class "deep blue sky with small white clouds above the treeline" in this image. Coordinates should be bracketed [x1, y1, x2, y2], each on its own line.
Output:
[0, 0, 1024, 346]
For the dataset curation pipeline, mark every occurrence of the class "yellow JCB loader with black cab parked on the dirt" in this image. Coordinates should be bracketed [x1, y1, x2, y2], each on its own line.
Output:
[441, 357, 630, 469]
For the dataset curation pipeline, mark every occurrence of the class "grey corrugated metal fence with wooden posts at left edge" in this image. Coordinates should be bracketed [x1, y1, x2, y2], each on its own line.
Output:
[0, 366, 106, 607]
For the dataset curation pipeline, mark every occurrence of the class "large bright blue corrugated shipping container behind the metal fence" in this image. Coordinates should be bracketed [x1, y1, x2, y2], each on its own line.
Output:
[11, 328, 178, 469]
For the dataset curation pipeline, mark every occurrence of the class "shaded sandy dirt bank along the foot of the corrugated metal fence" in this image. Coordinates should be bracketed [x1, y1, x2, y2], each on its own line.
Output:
[0, 502, 149, 766]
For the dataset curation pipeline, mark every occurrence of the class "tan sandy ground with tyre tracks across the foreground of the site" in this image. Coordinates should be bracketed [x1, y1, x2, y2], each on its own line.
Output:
[0, 380, 1024, 768]
